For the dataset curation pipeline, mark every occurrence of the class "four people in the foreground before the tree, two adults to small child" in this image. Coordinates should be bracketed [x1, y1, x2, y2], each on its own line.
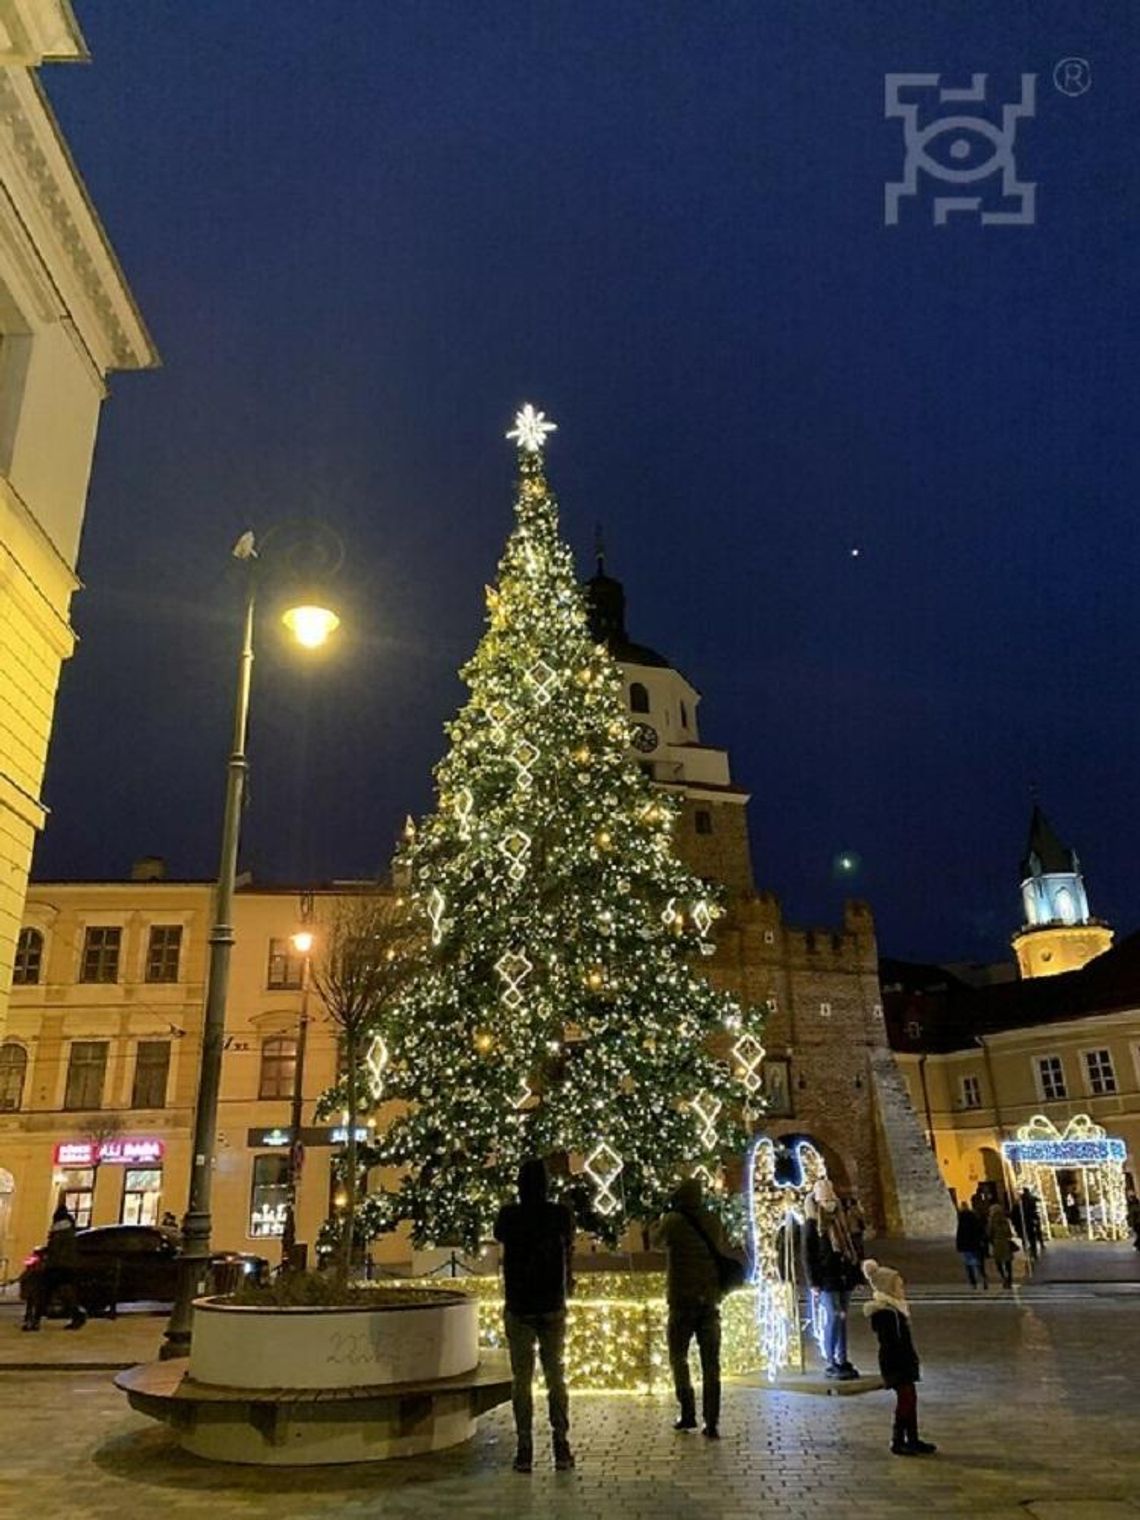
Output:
[494, 1158, 935, 1473]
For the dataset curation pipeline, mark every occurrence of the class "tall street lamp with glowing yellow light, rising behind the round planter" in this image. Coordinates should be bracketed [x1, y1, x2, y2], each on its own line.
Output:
[160, 530, 340, 1360]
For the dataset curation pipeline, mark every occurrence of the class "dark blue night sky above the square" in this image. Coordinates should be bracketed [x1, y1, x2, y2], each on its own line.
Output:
[35, 0, 1140, 959]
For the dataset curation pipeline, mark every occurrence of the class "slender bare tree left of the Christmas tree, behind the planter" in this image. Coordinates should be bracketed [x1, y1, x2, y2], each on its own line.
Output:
[312, 891, 418, 1281]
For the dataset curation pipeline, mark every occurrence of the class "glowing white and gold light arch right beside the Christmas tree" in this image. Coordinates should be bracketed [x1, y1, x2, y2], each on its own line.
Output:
[745, 1135, 827, 1382]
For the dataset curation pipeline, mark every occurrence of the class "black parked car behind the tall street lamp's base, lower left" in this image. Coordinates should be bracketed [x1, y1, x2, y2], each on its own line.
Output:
[20, 1225, 269, 1315]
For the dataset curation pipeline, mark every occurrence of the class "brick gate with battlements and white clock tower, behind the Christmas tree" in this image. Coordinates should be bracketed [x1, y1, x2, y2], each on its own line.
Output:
[587, 559, 953, 1236]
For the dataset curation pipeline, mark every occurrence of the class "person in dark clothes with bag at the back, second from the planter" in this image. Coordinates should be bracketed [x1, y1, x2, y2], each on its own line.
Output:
[654, 1176, 743, 1441]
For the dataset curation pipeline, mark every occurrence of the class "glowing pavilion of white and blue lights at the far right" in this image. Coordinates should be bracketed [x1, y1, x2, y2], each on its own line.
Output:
[1002, 1114, 1129, 1240]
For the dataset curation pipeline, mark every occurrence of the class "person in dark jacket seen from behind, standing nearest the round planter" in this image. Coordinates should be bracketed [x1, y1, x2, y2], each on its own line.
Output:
[494, 1158, 575, 1473]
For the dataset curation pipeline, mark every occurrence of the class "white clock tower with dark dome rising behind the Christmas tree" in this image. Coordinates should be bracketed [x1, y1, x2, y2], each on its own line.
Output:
[585, 556, 754, 892]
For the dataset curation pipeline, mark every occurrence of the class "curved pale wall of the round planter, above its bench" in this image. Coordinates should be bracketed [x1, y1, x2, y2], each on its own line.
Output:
[190, 1292, 479, 1389]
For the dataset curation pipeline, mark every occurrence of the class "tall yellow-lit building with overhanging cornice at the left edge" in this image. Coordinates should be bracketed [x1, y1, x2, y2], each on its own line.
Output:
[0, 0, 157, 1032]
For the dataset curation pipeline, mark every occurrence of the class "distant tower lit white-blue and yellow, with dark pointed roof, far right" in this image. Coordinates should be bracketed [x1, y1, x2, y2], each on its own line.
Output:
[1012, 803, 1113, 976]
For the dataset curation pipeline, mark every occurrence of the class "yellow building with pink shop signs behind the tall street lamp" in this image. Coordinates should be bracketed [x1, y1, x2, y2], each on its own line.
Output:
[0, 869, 384, 1277]
